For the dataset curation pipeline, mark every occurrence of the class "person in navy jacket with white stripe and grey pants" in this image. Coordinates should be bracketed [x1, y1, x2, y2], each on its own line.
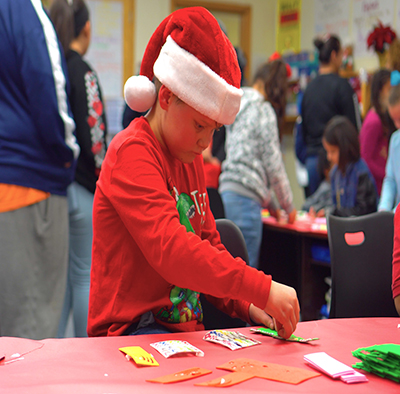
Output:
[0, 0, 79, 339]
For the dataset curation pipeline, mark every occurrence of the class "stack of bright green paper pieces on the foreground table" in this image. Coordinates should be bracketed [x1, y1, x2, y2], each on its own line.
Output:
[352, 343, 400, 383]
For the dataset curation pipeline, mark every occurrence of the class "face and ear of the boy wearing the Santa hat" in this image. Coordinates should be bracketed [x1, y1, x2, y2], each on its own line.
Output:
[155, 86, 222, 163]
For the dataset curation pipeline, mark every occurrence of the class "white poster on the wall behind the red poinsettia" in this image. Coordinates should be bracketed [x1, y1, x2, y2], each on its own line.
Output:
[353, 0, 395, 57]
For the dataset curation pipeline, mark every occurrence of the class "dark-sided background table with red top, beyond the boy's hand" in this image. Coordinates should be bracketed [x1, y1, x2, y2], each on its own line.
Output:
[259, 216, 331, 321]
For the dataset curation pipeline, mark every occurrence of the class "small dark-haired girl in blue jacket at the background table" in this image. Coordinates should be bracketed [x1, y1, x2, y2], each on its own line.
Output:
[318, 115, 378, 217]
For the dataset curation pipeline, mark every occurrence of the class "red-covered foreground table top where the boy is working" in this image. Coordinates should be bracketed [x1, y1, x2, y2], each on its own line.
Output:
[0, 318, 400, 394]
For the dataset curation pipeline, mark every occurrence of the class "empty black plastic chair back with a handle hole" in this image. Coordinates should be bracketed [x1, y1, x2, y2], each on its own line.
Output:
[327, 212, 398, 318]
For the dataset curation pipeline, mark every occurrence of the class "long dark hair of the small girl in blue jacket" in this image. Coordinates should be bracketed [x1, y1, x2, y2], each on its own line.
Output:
[323, 115, 361, 173]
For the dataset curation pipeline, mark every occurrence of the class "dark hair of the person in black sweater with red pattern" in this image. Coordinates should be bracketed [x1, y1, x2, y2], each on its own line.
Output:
[50, 0, 89, 54]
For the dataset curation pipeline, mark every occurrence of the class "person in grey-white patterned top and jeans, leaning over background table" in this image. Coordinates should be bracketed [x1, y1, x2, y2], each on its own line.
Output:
[219, 60, 296, 268]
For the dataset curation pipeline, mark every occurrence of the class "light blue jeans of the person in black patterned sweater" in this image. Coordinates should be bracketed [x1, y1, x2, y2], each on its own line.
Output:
[57, 182, 94, 338]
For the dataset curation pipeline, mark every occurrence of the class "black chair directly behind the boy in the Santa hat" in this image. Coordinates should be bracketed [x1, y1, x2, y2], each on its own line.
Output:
[200, 219, 249, 330]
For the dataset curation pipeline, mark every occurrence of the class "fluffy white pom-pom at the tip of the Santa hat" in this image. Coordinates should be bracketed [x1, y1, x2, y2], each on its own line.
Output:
[124, 75, 157, 112]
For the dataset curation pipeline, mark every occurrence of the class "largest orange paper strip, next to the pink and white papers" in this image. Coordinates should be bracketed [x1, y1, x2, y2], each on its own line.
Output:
[217, 358, 321, 384]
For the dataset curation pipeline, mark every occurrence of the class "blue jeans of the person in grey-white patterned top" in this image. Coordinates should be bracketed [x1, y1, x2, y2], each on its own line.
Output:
[221, 191, 262, 268]
